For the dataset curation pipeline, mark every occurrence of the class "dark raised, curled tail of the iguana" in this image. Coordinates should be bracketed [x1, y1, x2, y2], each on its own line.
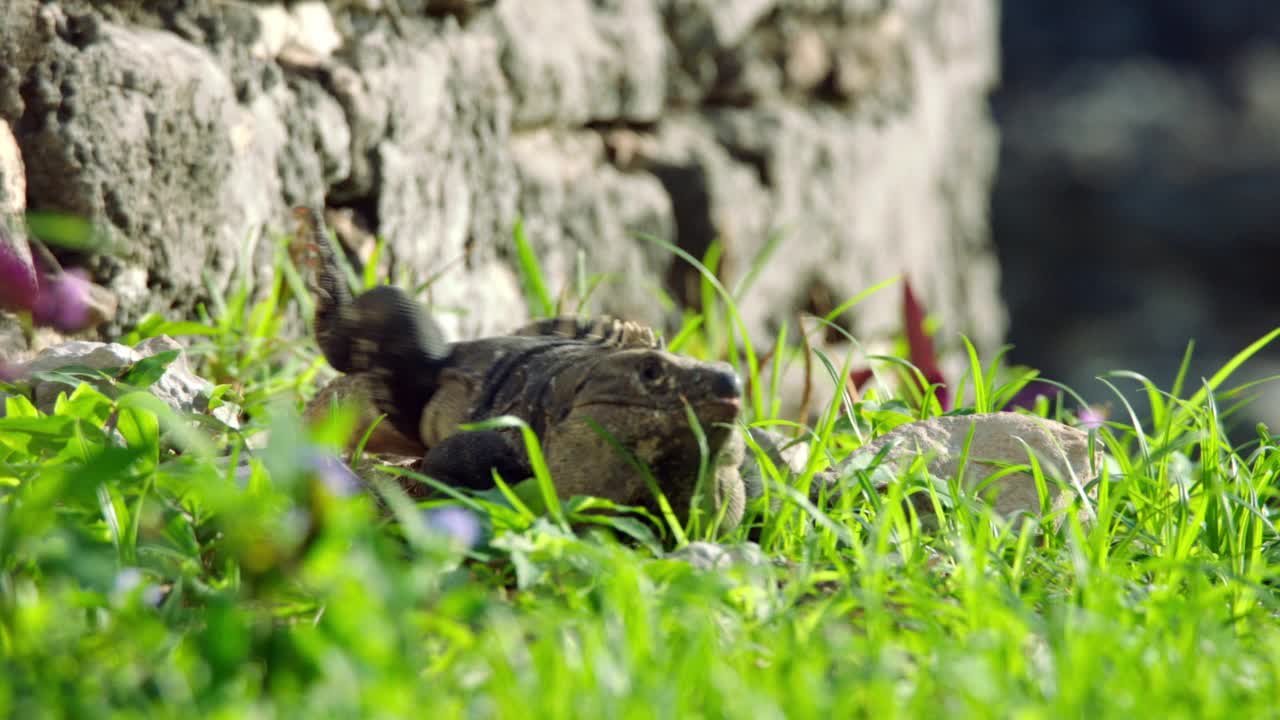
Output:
[293, 208, 449, 438]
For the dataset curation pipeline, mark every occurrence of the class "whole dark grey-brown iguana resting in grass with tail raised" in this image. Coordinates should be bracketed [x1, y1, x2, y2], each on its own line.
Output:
[294, 208, 745, 529]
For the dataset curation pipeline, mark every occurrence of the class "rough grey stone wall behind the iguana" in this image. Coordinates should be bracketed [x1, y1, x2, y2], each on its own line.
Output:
[0, 0, 1005, 358]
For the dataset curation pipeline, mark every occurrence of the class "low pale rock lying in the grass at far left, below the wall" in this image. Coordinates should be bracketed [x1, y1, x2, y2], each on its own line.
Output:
[11, 336, 239, 428]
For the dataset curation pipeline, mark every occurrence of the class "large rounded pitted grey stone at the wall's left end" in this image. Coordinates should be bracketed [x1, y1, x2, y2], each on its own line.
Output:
[17, 22, 283, 320]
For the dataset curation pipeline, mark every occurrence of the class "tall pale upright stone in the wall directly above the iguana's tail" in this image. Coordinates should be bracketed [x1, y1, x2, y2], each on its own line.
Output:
[338, 22, 524, 337]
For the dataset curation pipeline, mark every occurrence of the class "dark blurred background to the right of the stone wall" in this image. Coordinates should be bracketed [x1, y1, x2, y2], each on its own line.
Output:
[992, 0, 1280, 433]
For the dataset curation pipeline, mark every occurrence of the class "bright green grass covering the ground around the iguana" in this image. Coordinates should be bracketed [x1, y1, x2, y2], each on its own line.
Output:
[0, 221, 1280, 720]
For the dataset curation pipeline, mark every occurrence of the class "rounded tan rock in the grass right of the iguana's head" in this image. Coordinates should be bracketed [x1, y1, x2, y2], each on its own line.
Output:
[840, 413, 1102, 518]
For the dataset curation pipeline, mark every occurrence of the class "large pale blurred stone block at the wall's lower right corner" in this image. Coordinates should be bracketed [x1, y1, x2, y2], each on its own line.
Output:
[713, 98, 1005, 347]
